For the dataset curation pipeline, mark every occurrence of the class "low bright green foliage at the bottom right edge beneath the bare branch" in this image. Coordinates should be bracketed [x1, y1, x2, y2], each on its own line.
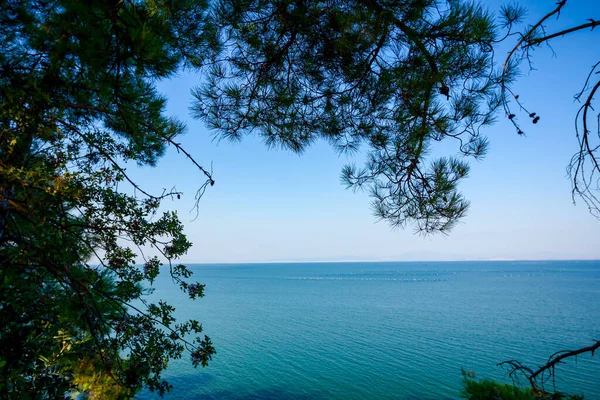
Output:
[461, 370, 583, 400]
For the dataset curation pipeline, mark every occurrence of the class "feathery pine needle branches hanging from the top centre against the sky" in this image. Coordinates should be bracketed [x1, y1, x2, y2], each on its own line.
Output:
[193, 0, 522, 233]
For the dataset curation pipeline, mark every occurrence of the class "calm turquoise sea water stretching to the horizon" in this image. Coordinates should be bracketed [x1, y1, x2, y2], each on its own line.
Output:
[139, 261, 600, 400]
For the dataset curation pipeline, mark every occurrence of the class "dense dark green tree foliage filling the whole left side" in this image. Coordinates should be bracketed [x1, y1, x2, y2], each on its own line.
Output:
[0, 0, 214, 399]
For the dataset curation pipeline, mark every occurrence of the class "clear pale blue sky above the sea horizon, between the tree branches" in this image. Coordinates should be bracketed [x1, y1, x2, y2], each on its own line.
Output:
[136, 0, 600, 262]
